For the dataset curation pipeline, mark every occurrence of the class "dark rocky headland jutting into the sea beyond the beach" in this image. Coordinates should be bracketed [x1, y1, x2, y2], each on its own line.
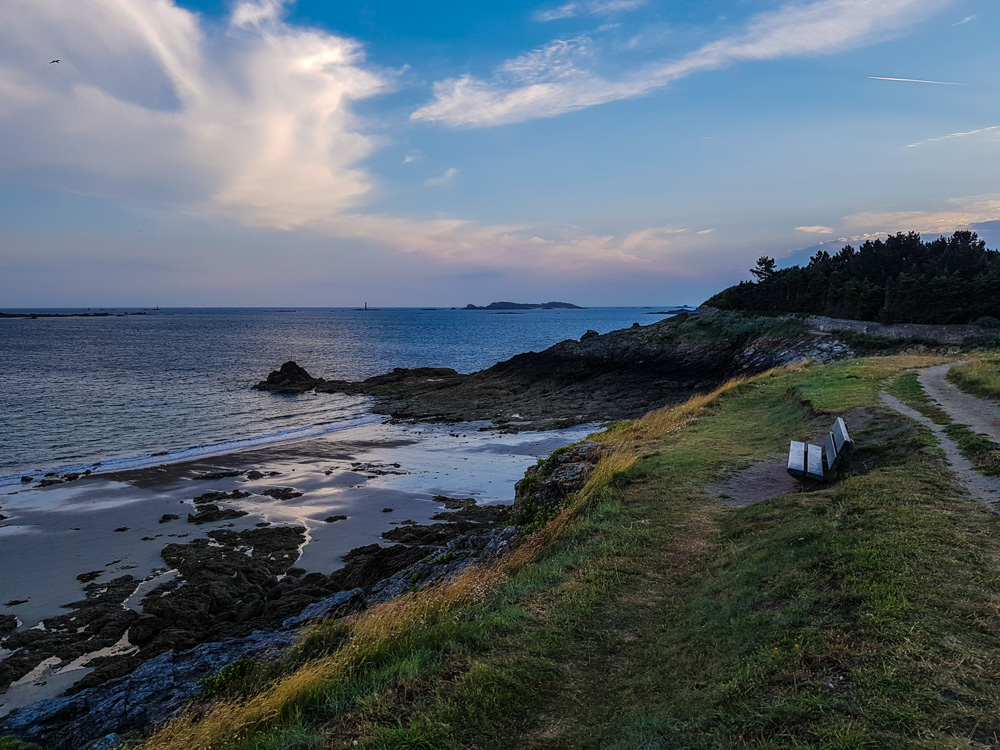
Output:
[255, 315, 853, 431]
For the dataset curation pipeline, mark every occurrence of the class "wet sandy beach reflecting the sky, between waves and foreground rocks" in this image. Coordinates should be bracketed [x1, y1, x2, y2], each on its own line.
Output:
[0, 421, 593, 715]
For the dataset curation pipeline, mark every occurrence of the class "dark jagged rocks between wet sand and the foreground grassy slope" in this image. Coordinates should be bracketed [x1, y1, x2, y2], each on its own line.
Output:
[0, 443, 602, 750]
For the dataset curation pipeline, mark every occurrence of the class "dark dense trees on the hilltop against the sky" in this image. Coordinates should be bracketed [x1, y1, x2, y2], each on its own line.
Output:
[705, 231, 1000, 324]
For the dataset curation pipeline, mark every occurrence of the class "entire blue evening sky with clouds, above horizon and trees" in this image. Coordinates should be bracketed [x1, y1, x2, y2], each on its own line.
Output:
[0, 0, 1000, 308]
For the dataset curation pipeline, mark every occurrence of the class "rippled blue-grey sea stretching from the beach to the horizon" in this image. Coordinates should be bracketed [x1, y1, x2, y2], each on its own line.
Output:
[0, 307, 688, 486]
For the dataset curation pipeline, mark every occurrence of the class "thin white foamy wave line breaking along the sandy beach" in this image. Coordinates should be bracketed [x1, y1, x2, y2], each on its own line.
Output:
[0, 414, 384, 487]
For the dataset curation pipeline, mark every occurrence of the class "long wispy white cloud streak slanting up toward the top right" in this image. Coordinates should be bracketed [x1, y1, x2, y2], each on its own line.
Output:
[411, 0, 950, 127]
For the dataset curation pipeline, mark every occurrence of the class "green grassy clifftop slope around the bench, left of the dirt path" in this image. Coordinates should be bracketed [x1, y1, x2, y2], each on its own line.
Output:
[103, 358, 1000, 750]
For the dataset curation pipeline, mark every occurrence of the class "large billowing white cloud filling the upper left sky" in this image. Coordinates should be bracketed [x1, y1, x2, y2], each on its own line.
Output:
[0, 0, 389, 228]
